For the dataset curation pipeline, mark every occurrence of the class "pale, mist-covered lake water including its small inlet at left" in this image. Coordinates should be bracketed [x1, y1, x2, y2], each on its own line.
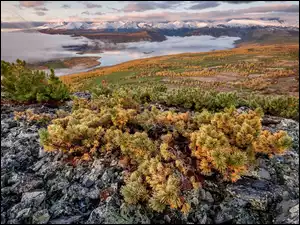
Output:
[1, 32, 240, 76]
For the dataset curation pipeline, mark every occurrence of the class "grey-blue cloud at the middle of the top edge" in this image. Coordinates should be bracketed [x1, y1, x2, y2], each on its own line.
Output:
[122, 1, 183, 12]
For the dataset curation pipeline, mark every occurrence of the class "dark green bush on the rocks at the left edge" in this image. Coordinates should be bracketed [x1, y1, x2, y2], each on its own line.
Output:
[1, 59, 69, 102]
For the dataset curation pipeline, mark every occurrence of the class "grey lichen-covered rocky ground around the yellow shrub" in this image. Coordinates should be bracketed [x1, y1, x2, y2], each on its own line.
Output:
[1, 97, 299, 224]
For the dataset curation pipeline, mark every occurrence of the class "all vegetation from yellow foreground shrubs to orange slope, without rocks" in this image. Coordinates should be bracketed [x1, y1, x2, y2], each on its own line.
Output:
[1, 45, 299, 214]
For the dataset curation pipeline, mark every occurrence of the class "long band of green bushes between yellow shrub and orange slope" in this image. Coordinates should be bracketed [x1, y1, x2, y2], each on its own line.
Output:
[92, 85, 299, 120]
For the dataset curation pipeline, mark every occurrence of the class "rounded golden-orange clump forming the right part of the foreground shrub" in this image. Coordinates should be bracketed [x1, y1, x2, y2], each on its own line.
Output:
[190, 106, 291, 181]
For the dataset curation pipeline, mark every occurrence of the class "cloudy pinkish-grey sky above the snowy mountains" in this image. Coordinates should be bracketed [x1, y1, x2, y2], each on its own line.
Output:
[1, 1, 299, 23]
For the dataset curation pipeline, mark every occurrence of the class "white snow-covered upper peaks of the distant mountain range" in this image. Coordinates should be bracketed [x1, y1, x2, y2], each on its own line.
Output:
[39, 19, 299, 30]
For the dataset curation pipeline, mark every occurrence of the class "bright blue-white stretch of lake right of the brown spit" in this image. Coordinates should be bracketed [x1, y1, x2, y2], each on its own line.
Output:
[90, 35, 240, 66]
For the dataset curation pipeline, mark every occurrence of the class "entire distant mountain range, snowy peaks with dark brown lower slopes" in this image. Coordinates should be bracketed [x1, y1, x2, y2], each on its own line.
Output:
[38, 19, 299, 43]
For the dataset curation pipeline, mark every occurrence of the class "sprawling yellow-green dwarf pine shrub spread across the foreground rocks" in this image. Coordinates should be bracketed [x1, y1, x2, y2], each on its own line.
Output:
[40, 86, 291, 213]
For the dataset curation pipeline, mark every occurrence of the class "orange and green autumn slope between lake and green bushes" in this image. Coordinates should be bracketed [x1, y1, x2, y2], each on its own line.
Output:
[61, 44, 299, 96]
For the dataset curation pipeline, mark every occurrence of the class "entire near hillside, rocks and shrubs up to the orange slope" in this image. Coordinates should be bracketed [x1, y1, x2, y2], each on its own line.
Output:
[1, 41, 299, 224]
